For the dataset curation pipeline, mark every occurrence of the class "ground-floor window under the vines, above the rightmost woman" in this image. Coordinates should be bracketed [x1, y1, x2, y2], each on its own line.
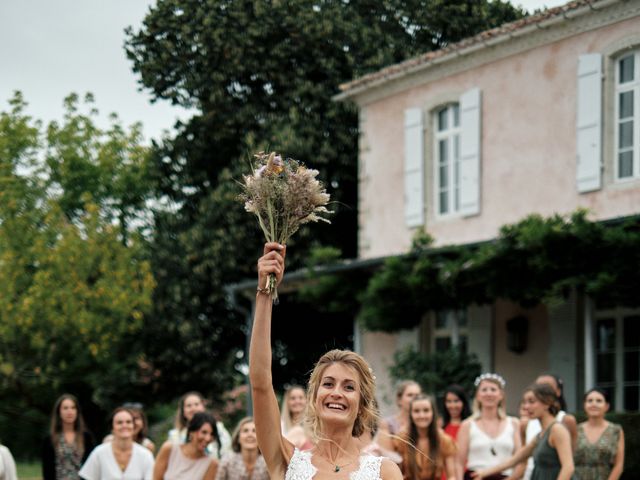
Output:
[594, 311, 640, 410]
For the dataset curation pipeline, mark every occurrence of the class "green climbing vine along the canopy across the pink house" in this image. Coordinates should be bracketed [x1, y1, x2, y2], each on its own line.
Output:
[359, 211, 640, 331]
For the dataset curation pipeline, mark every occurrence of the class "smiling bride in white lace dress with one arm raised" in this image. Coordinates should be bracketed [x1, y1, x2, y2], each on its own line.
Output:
[249, 243, 402, 480]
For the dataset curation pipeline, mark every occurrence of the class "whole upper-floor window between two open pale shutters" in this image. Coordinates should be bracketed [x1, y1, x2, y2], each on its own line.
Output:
[434, 107, 461, 215]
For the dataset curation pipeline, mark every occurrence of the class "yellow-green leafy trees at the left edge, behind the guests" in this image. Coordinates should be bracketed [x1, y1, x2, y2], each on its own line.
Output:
[0, 94, 154, 454]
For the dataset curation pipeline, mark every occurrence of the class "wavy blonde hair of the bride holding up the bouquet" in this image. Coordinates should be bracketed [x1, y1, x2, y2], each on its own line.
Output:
[305, 350, 380, 440]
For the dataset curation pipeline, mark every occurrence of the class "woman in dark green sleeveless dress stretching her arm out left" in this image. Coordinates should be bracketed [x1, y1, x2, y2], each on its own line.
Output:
[474, 383, 574, 480]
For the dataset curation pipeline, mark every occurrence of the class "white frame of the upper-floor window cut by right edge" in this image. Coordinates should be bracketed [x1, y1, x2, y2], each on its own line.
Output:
[613, 50, 640, 183]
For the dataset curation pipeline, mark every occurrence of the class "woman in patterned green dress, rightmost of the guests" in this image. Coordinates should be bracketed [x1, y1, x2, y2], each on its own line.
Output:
[574, 388, 624, 480]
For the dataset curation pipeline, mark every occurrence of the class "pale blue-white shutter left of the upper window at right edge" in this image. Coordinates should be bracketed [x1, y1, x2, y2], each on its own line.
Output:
[576, 53, 602, 193]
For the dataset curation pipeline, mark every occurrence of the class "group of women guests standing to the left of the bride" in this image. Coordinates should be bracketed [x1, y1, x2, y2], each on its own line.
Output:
[30, 392, 278, 480]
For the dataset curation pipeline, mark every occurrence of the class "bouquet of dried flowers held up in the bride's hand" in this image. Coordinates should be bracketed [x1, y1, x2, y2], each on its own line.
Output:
[240, 152, 333, 303]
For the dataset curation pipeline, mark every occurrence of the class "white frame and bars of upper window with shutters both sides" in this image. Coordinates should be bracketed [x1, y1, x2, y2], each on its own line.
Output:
[432, 102, 462, 219]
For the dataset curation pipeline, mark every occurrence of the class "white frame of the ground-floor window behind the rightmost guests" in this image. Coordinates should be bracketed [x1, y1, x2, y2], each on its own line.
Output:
[586, 308, 640, 411]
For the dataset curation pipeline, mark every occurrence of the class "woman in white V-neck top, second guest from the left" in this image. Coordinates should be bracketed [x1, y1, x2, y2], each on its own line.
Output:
[80, 407, 154, 480]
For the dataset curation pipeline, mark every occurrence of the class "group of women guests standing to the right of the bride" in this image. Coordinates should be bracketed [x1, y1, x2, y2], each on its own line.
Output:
[382, 373, 624, 480]
